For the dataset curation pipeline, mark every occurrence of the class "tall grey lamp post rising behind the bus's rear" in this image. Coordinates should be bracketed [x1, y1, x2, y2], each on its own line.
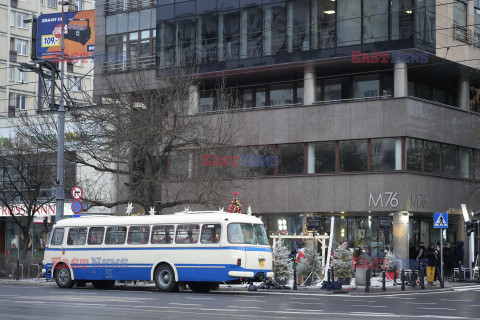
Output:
[55, 1, 70, 221]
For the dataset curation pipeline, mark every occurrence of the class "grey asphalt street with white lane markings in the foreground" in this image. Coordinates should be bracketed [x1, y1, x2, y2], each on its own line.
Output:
[0, 285, 480, 320]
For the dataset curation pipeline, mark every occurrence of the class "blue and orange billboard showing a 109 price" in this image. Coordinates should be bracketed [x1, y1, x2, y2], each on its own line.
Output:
[37, 10, 95, 61]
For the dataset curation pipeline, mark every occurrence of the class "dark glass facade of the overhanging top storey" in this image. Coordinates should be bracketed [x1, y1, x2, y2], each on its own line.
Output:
[157, 0, 435, 69]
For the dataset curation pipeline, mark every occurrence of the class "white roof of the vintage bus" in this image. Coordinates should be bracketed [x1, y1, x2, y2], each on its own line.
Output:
[55, 211, 262, 227]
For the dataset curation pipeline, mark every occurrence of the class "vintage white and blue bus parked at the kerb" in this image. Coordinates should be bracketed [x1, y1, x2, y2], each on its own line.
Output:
[43, 211, 273, 292]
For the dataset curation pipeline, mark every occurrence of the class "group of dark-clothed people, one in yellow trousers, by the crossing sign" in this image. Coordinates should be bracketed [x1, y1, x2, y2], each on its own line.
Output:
[410, 242, 465, 286]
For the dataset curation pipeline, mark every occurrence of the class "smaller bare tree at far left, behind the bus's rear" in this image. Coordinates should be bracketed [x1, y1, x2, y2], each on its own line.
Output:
[0, 136, 65, 258]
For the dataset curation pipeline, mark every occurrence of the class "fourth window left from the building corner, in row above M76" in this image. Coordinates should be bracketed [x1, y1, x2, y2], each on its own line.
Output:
[278, 143, 305, 174]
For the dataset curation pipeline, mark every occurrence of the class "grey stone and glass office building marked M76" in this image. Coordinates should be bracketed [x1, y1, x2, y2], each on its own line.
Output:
[95, 0, 480, 264]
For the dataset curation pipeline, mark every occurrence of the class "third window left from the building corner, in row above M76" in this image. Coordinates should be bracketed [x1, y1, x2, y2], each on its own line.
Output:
[307, 141, 335, 173]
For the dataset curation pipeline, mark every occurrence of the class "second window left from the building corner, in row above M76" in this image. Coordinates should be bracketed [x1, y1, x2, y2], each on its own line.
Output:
[338, 140, 368, 172]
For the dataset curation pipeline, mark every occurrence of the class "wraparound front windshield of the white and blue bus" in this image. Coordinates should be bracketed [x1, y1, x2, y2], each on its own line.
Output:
[227, 223, 268, 245]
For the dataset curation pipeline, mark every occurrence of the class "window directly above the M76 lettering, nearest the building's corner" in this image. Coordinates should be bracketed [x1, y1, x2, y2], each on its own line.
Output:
[371, 138, 402, 171]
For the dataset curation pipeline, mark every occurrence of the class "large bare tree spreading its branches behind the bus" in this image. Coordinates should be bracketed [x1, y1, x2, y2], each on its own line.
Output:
[18, 67, 246, 212]
